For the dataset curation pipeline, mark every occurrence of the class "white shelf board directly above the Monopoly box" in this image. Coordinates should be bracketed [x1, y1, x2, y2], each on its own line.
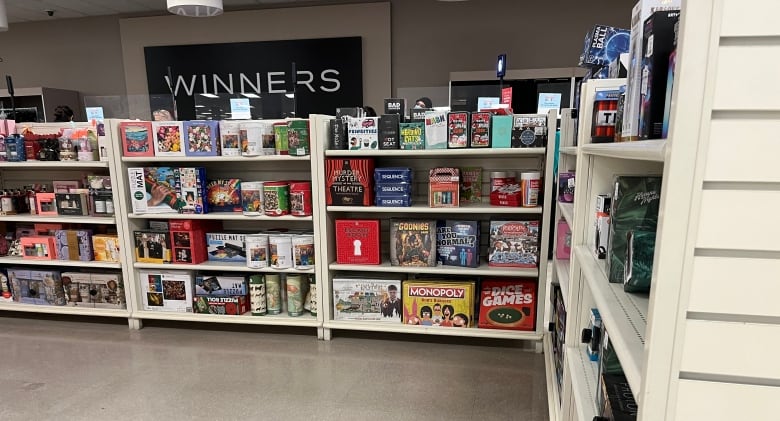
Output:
[328, 259, 539, 278]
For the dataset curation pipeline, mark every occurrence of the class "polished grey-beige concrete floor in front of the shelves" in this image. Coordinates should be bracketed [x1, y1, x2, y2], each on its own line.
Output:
[0, 317, 547, 421]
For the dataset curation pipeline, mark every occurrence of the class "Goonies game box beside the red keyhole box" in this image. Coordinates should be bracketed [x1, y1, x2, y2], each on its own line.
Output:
[390, 219, 436, 266]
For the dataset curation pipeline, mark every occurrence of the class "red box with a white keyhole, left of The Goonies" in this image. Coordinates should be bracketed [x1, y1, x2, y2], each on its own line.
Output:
[335, 219, 381, 265]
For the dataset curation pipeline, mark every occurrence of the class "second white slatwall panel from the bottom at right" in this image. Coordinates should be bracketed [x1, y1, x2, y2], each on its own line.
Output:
[680, 320, 780, 378]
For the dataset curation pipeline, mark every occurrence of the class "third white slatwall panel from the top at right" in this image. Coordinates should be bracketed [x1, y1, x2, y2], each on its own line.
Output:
[704, 119, 780, 182]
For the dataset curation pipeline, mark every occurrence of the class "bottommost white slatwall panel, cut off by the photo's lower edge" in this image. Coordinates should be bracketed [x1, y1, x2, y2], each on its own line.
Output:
[675, 380, 780, 421]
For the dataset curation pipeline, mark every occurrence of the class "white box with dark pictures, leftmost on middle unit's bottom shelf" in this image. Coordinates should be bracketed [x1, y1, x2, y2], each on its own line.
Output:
[138, 270, 193, 313]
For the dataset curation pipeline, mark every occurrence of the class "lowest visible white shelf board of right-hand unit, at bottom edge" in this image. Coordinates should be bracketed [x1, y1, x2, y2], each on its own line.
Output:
[565, 345, 598, 421]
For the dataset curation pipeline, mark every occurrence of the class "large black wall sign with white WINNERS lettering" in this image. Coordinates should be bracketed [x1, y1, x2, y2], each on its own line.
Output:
[144, 37, 363, 120]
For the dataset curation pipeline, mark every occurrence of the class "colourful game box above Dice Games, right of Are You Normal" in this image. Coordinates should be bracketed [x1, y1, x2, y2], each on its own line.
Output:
[488, 221, 539, 268]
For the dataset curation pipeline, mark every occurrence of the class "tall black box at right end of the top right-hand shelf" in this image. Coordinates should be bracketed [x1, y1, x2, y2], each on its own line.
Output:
[639, 10, 680, 139]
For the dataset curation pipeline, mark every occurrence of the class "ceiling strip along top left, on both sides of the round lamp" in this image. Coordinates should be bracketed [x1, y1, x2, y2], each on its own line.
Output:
[5, 0, 367, 23]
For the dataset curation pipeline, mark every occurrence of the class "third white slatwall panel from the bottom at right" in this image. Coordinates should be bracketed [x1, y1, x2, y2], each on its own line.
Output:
[688, 256, 780, 317]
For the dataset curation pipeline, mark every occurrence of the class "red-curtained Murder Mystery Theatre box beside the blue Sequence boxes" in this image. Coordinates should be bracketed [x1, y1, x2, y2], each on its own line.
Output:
[325, 158, 374, 206]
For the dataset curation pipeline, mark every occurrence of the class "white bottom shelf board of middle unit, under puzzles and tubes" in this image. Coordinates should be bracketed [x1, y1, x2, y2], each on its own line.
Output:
[132, 310, 321, 327]
